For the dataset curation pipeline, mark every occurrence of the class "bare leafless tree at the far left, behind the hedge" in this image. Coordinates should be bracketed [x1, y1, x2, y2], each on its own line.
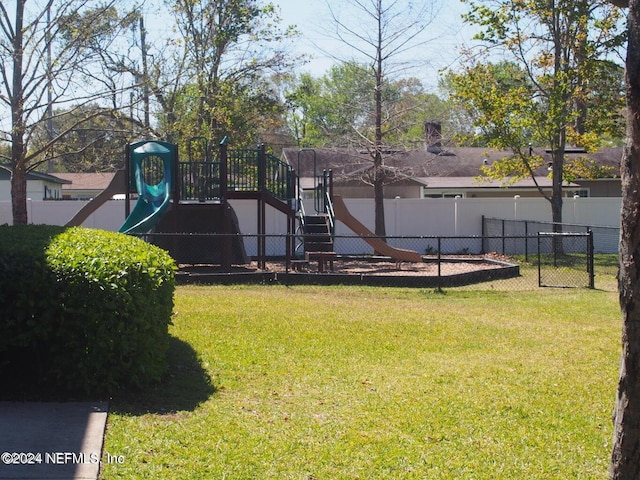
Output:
[0, 0, 139, 224]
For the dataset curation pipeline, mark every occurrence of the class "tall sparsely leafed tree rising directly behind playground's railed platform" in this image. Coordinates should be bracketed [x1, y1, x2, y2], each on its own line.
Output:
[124, 0, 297, 149]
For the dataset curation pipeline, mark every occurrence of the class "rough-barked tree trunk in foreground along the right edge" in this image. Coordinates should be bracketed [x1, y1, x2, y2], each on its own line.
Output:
[609, 0, 640, 480]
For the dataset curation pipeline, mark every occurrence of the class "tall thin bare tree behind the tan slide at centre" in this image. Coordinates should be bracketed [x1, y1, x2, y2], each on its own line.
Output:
[320, 0, 437, 237]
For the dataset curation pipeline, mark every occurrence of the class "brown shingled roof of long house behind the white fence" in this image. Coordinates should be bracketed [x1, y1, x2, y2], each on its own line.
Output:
[283, 147, 622, 184]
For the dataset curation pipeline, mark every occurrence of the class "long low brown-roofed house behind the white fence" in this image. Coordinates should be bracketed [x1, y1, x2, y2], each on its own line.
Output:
[283, 145, 622, 198]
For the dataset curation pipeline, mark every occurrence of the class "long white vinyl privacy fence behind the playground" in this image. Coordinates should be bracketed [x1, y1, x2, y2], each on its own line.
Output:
[0, 198, 621, 237]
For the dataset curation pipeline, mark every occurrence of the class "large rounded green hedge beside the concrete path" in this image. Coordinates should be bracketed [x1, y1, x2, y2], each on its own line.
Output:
[0, 225, 175, 393]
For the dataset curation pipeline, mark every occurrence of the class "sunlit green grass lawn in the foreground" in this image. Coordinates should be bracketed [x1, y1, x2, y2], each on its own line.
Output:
[102, 286, 620, 480]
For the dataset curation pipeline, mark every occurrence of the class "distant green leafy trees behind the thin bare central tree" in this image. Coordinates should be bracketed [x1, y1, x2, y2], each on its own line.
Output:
[286, 62, 457, 149]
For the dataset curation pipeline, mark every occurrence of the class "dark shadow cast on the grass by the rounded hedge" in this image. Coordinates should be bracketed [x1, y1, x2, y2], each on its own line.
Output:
[109, 337, 216, 415]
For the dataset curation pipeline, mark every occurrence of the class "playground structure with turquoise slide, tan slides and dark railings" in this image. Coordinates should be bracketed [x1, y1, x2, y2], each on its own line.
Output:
[67, 137, 422, 272]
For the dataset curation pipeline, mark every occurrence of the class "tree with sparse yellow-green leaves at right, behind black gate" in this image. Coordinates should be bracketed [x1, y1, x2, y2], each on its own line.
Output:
[452, 0, 625, 223]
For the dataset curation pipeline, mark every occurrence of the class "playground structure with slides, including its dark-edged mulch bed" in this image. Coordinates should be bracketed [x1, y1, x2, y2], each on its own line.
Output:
[67, 137, 519, 287]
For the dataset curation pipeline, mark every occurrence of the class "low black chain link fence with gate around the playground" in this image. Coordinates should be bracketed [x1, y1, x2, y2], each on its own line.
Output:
[131, 233, 615, 290]
